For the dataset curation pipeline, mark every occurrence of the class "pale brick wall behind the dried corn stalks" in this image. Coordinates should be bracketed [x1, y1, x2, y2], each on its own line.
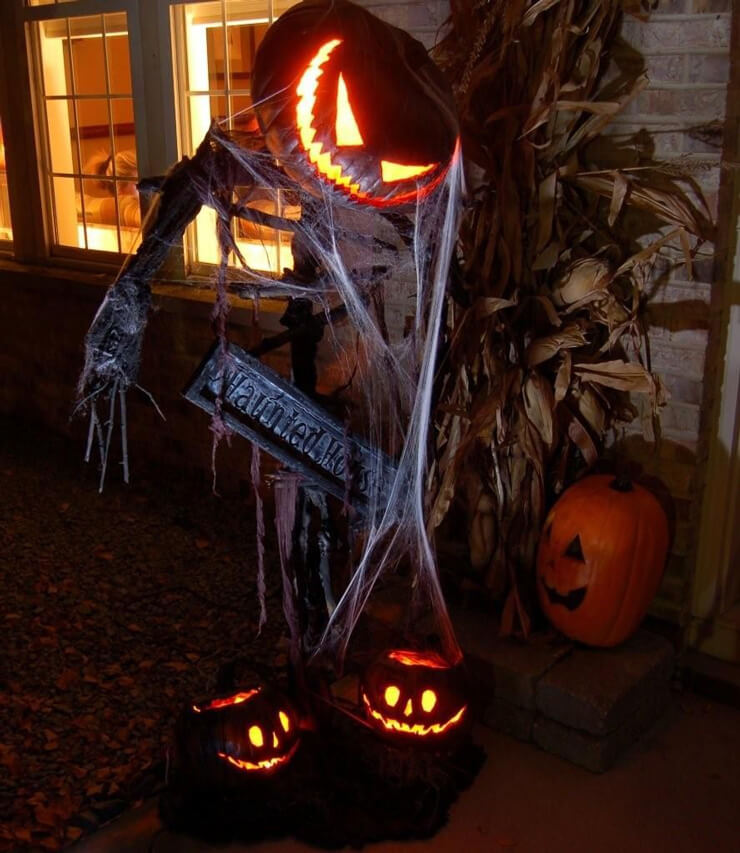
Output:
[359, 0, 732, 618]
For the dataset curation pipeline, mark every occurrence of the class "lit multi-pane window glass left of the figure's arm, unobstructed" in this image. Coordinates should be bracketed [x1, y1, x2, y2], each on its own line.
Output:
[33, 10, 141, 253]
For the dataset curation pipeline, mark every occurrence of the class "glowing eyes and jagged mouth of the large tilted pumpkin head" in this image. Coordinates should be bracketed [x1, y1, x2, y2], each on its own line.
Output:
[296, 39, 460, 207]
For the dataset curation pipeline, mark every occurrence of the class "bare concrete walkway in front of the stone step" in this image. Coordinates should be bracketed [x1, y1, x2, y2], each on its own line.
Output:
[73, 694, 740, 853]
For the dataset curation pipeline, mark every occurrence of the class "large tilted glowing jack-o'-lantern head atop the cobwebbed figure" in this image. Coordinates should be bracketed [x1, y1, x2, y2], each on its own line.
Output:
[252, 0, 459, 208]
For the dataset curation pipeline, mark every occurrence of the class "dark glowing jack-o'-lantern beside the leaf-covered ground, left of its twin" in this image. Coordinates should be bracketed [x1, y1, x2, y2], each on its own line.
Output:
[178, 687, 300, 782]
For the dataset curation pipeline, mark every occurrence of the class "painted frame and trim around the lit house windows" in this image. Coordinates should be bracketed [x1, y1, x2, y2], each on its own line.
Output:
[0, 0, 300, 284]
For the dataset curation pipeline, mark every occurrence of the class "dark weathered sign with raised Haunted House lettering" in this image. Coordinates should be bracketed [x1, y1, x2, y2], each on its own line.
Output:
[184, 344, 396, 514]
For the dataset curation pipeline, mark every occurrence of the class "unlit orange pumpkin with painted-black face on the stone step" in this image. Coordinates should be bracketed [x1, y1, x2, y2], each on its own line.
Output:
[537, 475, 668, 646]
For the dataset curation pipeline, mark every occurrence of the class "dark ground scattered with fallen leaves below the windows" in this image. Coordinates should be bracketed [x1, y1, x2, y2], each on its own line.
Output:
[0, 419, 283, 851]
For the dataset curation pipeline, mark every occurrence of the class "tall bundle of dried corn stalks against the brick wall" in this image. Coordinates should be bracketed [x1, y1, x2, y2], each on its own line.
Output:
[430, 0, 711, 634]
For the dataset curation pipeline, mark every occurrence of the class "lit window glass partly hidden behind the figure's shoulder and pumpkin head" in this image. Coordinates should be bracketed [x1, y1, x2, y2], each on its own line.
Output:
[174, 0, 300, 273]
